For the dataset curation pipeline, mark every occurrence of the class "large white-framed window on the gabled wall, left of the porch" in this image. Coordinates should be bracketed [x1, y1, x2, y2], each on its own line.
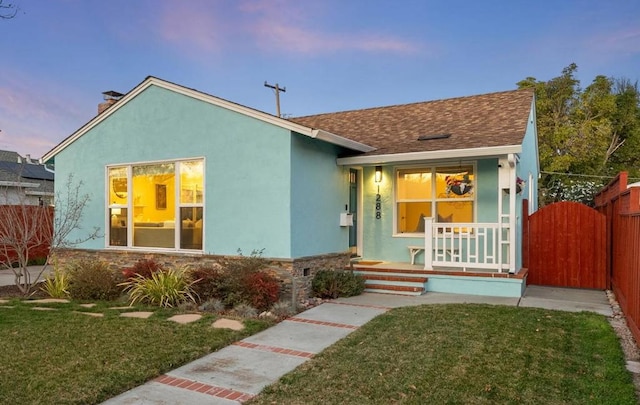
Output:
[107, 160, 204, 250]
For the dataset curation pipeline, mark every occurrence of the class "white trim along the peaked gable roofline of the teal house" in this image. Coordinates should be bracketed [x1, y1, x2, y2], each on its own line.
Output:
[41, 76, 375, 162]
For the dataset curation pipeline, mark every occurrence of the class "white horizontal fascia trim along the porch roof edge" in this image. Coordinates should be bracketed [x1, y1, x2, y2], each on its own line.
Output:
[336, 145, 522, 166]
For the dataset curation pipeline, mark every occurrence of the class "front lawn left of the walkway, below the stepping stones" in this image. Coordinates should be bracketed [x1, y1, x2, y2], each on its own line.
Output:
[0, 300, 272, 404]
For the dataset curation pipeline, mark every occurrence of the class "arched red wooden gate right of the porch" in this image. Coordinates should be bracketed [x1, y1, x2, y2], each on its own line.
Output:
[523, 201, 607, 290]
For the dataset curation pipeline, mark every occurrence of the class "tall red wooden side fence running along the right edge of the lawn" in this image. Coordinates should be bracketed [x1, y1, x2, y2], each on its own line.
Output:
[595, 172, 640, 342]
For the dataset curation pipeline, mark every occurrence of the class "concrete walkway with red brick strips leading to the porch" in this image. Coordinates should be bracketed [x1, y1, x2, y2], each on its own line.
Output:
[105, 286, 612, 405]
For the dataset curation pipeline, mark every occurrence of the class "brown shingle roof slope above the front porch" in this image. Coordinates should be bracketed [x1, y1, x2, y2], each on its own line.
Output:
[291, 89, 533, 155]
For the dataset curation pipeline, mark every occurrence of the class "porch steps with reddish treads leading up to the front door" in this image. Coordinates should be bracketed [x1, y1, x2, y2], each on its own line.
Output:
[353, 265, 427, 295]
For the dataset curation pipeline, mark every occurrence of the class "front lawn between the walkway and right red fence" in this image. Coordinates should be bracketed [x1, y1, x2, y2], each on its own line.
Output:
[250, 304, 637, 404]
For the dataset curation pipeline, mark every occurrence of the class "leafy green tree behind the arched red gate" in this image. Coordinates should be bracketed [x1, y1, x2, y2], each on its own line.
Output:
[518, 63, 640, 204]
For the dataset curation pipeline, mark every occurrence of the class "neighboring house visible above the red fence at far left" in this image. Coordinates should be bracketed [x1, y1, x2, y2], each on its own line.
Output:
[0, 150, 54, 205]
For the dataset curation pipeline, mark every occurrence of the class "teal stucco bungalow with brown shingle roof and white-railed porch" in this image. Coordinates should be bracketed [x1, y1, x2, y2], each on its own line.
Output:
[43, 77, 539, 298]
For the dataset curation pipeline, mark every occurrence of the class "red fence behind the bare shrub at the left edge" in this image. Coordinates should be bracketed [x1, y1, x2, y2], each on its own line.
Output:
[0, 205, 53, 266]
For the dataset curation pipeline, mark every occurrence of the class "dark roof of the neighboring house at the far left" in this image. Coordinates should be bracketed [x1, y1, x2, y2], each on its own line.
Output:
[0, 150, 54, 185]
